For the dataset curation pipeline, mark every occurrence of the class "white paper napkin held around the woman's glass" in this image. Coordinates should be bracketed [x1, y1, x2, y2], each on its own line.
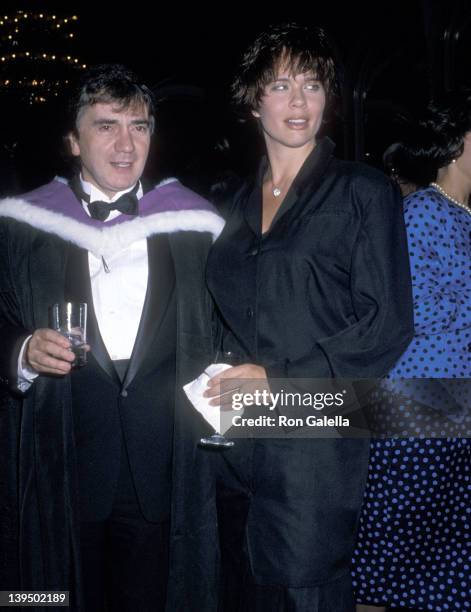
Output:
[183, 363, 243, 435]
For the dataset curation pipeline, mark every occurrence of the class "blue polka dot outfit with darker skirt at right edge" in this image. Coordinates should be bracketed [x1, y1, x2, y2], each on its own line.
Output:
[353, 187, 471, 612]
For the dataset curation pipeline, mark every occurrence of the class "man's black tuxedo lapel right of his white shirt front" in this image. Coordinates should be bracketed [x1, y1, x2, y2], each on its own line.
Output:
[123, 234, 175, 388]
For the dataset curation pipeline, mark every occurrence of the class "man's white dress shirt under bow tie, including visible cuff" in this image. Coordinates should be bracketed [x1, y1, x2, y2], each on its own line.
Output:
[18, 177, 149, 391]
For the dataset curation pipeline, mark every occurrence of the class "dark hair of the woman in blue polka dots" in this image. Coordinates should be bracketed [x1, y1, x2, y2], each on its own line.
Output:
[414, 90, 471, 170]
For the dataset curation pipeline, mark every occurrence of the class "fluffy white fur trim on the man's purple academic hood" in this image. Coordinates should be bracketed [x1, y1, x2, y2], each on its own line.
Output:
[0, 198, 224, 257]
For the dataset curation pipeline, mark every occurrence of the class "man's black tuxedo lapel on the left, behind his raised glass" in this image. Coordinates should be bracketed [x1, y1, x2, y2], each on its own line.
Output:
[64, 244, 121, 385]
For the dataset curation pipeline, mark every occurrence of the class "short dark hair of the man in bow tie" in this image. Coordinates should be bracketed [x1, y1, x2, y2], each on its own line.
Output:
[68, 64, 154, 130]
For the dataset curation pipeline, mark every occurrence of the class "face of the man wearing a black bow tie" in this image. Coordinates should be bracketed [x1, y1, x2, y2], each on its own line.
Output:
[70, 102, 151, 197]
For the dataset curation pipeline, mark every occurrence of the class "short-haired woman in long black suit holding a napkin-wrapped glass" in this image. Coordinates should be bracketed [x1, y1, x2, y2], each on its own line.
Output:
[207, 24, 413, 612]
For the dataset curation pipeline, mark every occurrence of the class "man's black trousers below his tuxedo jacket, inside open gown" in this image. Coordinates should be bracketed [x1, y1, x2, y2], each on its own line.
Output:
[80, 445, 169, 612]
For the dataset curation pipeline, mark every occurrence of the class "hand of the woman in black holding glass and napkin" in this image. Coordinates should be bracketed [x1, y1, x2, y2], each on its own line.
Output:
[204, 363, 270, 410]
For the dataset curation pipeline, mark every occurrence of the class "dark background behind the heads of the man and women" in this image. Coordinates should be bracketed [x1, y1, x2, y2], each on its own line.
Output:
[0, 0, 471, 194]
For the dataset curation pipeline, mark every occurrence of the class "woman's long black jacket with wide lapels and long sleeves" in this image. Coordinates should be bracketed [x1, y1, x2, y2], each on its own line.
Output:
[207, 140, 413, 587]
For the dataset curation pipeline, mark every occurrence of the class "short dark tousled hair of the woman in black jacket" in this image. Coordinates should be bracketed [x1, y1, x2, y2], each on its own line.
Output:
[232, 23, 339, 112]
